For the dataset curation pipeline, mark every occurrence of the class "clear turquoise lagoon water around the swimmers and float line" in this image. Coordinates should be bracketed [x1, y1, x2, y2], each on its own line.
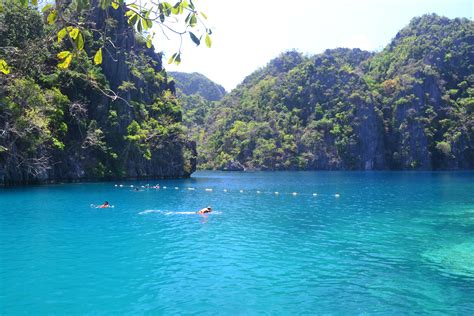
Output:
[0, 172, 474, 315]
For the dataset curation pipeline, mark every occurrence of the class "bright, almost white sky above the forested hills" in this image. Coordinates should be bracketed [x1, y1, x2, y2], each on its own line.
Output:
[155, 0, 474, 91]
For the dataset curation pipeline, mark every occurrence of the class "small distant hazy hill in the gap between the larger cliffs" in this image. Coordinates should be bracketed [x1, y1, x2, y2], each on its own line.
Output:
[169, 72, 226, 101]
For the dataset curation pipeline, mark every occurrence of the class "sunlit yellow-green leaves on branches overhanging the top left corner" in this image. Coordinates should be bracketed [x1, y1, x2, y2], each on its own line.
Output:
[0, 0, 212, 74]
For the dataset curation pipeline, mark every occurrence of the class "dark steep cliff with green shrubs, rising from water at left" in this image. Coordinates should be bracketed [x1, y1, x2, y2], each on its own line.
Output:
[0, 1, 195, 184]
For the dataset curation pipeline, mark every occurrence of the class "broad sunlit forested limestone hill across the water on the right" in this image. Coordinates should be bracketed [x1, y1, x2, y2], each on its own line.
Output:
[195, 15, 474, 170]
